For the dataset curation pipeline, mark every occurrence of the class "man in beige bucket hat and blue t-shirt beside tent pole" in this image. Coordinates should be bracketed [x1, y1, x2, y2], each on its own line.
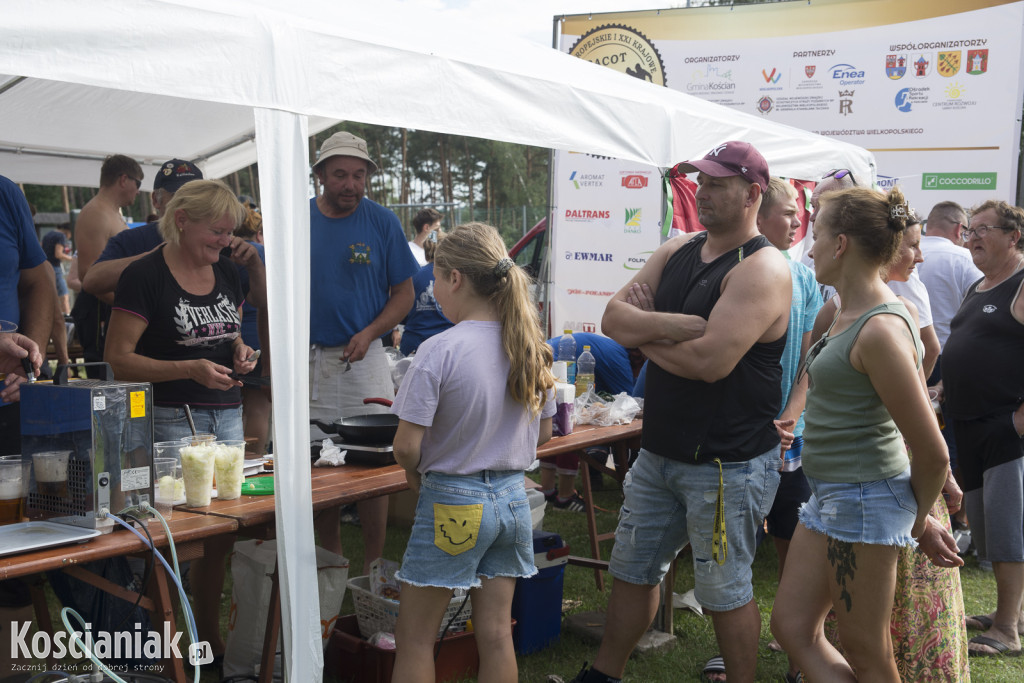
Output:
[309, 131, 419, 573]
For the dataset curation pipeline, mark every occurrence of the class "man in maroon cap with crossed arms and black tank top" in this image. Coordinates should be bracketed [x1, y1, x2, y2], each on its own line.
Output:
[575, 141, 792, 683]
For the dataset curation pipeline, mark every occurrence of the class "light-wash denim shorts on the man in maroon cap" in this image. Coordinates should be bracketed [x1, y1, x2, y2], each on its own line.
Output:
[609, 445, 781, 611]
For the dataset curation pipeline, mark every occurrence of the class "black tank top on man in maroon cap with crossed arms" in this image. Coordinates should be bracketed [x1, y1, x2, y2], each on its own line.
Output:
[643, 232, 785, 463]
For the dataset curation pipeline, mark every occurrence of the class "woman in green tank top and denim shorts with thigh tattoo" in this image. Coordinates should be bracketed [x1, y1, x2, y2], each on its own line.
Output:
[772, 188, 948, 681]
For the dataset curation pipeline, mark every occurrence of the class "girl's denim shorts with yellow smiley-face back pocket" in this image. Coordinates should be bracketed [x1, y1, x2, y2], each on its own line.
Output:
[395, 470, 537, 589]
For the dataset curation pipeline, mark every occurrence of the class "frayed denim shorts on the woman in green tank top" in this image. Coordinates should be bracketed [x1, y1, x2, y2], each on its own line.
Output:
[800, 467, 918, 548]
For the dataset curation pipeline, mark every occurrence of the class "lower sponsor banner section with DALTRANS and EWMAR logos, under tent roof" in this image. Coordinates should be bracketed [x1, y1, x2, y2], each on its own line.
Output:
[550, 153, 671, 333]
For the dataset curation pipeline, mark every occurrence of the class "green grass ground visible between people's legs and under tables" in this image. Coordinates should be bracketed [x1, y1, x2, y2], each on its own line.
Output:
[28, 478, 1024, 683]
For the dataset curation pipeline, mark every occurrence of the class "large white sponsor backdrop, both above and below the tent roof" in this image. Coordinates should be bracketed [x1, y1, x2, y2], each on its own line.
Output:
[551, 0, 1024, 331]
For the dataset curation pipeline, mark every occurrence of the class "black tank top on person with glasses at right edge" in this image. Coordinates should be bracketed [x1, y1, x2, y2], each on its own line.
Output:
[942, 270, 1024, 420]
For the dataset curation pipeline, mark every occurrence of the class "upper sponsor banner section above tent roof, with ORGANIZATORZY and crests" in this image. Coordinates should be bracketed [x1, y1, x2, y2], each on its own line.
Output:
[561, 0, 1024, 213]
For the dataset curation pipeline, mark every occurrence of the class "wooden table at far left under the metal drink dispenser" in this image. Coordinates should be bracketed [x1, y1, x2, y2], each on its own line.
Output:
[0, 511, 239, 681]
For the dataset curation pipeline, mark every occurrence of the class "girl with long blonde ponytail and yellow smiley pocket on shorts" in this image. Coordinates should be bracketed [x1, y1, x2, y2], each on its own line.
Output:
[392, 223, 555, 682]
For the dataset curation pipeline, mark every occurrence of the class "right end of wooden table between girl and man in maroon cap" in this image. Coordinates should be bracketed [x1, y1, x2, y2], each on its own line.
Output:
[537, 420, 643, 591]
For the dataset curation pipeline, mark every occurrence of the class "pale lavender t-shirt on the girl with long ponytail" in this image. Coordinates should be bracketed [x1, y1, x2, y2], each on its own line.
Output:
[391, 321, 555, 474]
